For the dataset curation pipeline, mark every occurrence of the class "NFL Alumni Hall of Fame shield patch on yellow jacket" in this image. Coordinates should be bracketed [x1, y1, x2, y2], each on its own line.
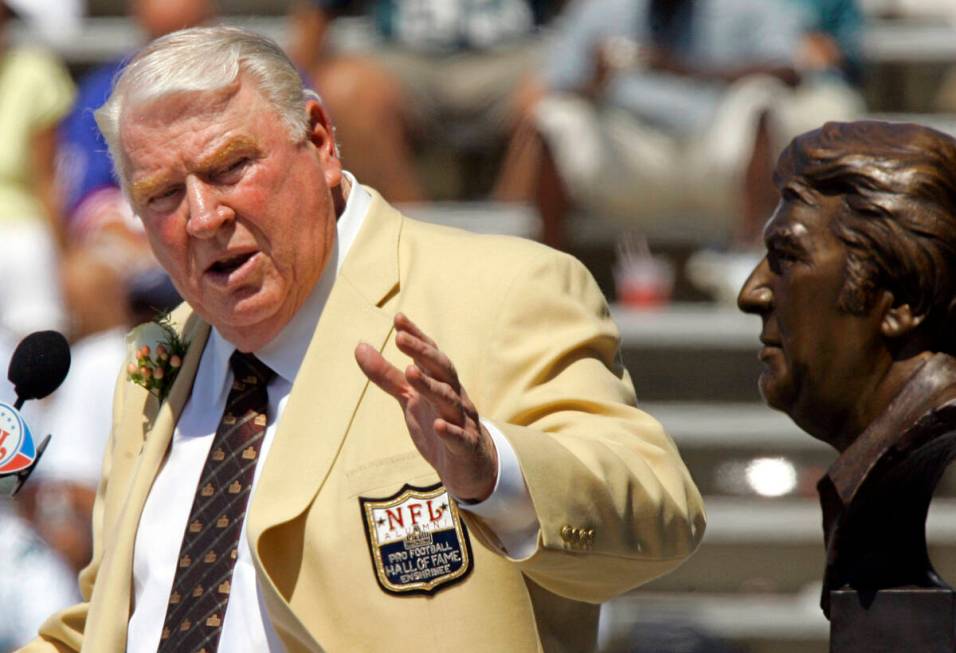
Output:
[359, 484, 474, 594]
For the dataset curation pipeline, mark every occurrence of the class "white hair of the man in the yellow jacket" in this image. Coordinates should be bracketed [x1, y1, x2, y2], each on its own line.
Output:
[96, 26, 319, 187]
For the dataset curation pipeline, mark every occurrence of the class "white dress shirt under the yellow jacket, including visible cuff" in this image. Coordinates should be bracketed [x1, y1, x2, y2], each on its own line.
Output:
[127, 172, 538, 653]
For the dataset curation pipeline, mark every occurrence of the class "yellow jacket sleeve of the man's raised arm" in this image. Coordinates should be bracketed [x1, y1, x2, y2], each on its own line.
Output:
[467, 250, 705, 602]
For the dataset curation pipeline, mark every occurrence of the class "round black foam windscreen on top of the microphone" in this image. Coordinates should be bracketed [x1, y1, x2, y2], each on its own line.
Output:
[7, 331, 70, 401]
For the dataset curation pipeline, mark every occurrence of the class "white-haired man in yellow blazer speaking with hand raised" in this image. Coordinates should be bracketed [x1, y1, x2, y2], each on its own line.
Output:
[22, 28, 704, 651]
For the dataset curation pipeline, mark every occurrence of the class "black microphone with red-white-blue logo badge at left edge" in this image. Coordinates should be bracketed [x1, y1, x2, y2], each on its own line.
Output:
[0, 331, 70, 496]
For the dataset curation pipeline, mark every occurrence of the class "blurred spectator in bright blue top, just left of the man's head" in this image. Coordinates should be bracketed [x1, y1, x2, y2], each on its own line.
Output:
[58, 0, 214, 338]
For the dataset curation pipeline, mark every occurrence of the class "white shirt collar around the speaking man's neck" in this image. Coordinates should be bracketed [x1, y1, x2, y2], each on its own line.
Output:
[203, 170, 372, 392]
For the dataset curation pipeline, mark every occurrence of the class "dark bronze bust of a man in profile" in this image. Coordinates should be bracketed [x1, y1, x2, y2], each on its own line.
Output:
[738, 122, 956, 616]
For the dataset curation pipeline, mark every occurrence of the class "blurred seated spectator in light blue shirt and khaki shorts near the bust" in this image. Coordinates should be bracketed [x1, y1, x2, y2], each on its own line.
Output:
[534, 0, 857, 244]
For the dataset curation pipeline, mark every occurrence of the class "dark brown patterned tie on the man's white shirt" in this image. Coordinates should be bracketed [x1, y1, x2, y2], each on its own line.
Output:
[159, 351, 275, 653]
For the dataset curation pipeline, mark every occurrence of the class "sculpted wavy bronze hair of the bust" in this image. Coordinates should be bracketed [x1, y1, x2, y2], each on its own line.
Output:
[774, 121, 956, 353]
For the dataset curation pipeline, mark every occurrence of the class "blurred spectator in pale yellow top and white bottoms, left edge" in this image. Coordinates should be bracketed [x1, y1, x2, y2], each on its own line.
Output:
[0, 0, 73, 336]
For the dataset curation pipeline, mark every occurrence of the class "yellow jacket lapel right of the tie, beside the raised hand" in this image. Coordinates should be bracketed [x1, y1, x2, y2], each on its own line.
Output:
[248, 192, 402, 650]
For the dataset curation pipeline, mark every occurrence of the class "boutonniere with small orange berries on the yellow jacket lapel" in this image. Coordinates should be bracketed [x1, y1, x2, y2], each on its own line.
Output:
[126, 313, 189, 401]
